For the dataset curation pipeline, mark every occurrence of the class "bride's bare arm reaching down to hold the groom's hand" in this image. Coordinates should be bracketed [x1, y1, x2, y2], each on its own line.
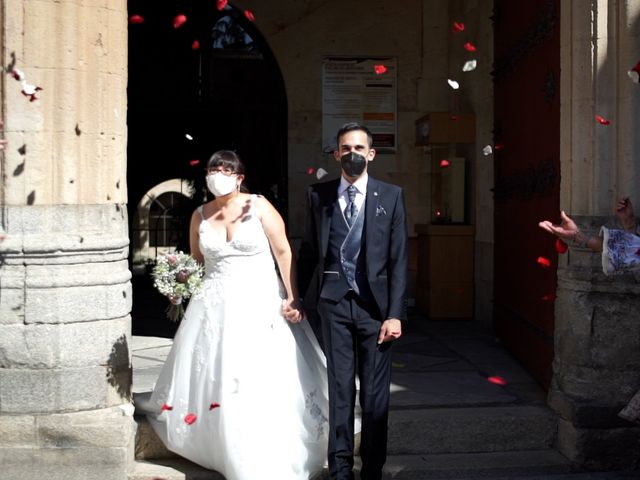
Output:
[256, 197, 303, 322]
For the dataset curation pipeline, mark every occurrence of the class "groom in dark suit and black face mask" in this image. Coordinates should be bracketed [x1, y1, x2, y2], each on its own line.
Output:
[298, 123, 407, 480]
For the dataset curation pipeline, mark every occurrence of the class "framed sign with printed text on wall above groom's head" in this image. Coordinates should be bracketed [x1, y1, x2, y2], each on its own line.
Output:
[322, 57, 398, 153]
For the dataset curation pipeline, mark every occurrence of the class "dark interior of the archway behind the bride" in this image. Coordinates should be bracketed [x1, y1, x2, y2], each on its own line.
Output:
[127, 0, 287, 335]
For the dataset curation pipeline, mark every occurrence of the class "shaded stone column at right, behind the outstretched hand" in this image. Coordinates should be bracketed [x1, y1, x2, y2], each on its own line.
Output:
[549, 0, 640, 469]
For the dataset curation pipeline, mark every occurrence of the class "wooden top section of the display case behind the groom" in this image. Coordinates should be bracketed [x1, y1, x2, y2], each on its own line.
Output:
[416, 112, 476, 146]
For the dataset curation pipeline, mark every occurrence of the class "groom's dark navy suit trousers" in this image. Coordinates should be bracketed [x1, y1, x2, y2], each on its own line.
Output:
[318, 291, 391, 480]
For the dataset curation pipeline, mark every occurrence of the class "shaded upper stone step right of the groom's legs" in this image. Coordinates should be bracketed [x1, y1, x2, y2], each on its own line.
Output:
[388, 405, 557, 455]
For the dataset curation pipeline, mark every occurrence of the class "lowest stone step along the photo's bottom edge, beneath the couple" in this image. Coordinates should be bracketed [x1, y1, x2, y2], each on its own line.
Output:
[129, 450, 570, 480]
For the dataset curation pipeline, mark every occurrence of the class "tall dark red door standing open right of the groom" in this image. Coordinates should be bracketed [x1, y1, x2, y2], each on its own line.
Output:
[493, 0, 560, 387]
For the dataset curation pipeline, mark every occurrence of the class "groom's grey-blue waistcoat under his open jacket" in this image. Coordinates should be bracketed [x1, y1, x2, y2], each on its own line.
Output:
[320, 202, 372, 302]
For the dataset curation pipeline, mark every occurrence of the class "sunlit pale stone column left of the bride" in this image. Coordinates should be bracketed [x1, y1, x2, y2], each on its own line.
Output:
[0, 0, 134, 480]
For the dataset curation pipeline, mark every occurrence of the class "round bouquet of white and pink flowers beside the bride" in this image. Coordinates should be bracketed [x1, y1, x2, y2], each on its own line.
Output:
[152, 251, 204, 322]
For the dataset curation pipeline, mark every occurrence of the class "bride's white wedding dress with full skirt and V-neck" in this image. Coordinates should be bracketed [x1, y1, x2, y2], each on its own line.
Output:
[149, 197, 328, 480]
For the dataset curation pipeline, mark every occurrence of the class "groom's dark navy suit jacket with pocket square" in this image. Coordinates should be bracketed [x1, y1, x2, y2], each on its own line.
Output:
[298, 177, 407, 320]
